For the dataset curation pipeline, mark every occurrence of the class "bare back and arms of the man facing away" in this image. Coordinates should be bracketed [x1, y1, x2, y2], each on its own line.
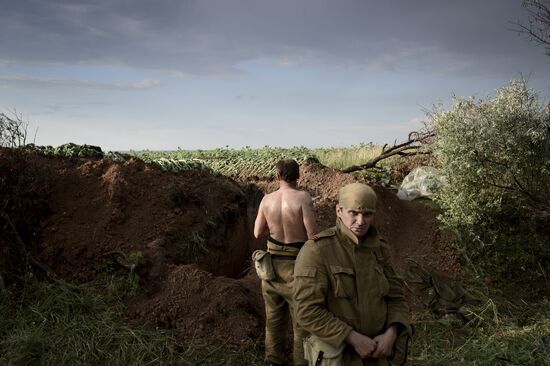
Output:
[254, 186, 316, 243]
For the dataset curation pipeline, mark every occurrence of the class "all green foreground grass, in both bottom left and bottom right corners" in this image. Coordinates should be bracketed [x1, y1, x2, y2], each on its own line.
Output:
[0, 276, 550, 366]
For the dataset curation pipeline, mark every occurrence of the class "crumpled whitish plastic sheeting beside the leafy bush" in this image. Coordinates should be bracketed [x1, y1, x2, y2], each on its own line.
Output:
[397, 166, 446, 201]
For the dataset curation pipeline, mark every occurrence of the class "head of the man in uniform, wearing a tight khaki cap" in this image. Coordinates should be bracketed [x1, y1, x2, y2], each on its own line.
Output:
[336, 183, 376, 238]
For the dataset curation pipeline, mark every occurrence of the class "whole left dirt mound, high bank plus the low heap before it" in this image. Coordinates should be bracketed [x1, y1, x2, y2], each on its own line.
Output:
[0, 151, 262, 342]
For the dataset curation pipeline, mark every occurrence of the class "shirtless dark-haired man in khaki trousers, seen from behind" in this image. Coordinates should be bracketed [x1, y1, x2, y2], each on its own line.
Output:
[254, 160, 316, 366]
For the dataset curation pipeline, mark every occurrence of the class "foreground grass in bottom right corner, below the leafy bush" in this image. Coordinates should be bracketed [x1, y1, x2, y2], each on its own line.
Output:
[410, 288, 550, 366]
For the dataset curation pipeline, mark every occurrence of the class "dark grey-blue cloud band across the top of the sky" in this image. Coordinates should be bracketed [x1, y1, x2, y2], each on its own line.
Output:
[0, 0, 549, 77]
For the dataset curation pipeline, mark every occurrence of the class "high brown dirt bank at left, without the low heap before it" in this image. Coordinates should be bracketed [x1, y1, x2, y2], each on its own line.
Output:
[35, 159, 248, 281]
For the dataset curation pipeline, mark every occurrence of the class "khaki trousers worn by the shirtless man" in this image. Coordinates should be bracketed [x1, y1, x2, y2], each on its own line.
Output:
[262, 259, 307, 366]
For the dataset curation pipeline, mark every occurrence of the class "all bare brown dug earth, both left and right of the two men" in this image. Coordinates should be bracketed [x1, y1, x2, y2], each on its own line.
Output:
[0, 150, 463, 345]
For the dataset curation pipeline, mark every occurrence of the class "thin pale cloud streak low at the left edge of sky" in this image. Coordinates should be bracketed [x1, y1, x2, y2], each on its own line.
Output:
[0, 73, 161, 90]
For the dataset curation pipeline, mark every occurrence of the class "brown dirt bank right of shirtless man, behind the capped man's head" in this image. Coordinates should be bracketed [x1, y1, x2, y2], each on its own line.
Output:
[299, 164, 463, 278]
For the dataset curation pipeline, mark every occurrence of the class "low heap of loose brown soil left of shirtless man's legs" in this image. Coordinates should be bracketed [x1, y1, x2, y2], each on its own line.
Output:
[129, 265, 263, 344]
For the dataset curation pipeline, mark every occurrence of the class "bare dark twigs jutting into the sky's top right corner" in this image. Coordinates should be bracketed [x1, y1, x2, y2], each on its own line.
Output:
[512, 0, 550, 56]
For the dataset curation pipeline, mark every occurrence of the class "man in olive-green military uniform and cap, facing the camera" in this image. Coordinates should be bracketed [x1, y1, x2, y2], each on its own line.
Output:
[293, 183, 411, 366]
